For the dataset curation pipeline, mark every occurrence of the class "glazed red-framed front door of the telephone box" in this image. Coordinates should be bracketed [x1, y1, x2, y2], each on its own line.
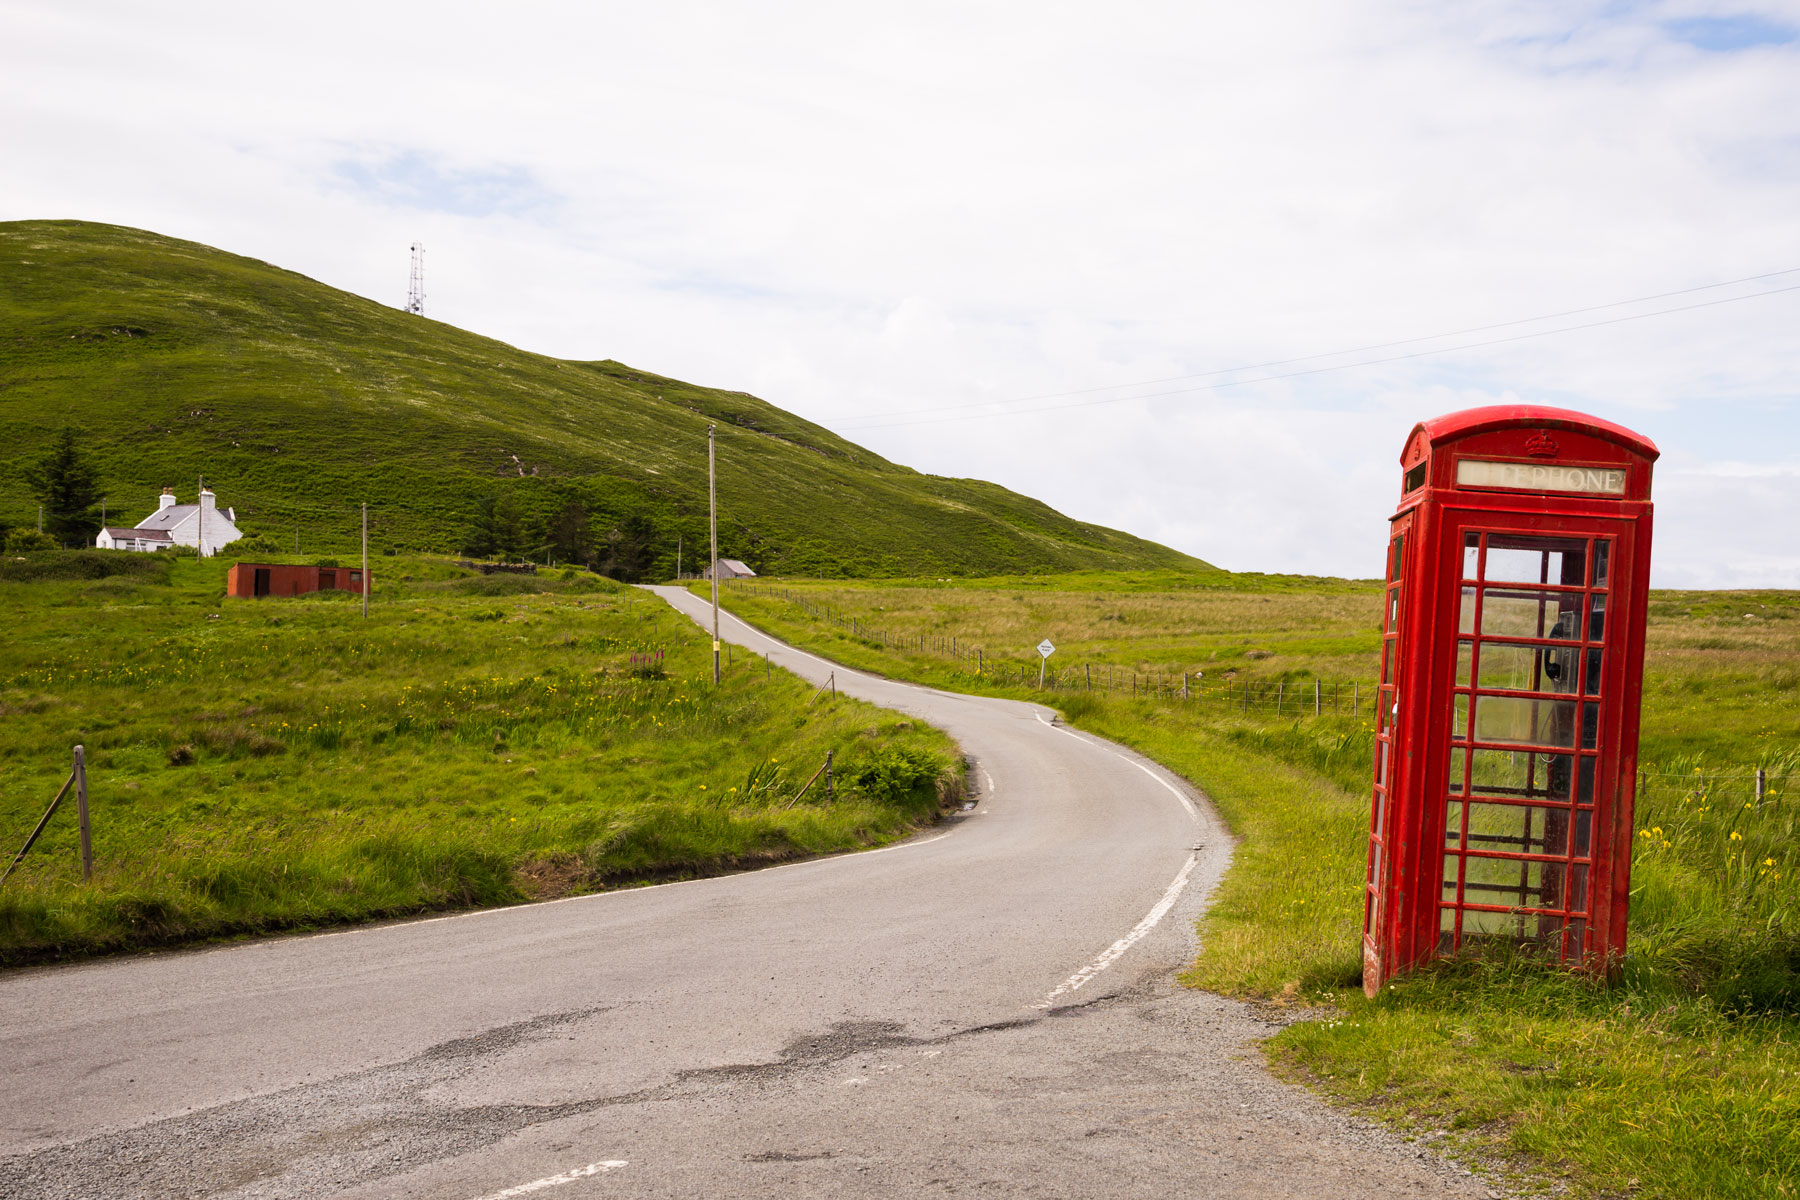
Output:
[1418, 509, 1642, 963]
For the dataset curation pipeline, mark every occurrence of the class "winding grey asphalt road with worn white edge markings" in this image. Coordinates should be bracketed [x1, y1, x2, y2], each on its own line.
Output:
[0, 588, 1490, 1200]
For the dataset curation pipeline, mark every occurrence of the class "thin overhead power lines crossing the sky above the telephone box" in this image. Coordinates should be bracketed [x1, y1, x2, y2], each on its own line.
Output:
[837, 278, 1800, 434]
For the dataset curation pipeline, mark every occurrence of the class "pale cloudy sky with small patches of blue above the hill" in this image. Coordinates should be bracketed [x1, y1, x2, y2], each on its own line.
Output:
[0, 0, 1800, 588]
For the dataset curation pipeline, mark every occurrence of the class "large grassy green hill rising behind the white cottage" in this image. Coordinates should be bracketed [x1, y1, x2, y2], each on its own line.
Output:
[0, 221, 1208, 576]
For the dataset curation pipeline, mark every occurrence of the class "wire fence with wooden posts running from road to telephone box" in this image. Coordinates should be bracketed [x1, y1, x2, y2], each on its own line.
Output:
[727, 581, 1375, 718]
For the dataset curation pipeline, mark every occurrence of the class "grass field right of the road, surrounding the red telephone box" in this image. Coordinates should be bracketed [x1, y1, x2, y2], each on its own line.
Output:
[705, 574, 1800, 1200]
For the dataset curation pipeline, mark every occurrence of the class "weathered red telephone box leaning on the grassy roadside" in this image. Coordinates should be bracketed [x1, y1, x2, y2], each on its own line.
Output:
[1363, 405, 1658, 995]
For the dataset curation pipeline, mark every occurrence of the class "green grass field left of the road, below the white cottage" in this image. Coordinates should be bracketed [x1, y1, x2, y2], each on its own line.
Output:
[0, 551, 959, 964]
